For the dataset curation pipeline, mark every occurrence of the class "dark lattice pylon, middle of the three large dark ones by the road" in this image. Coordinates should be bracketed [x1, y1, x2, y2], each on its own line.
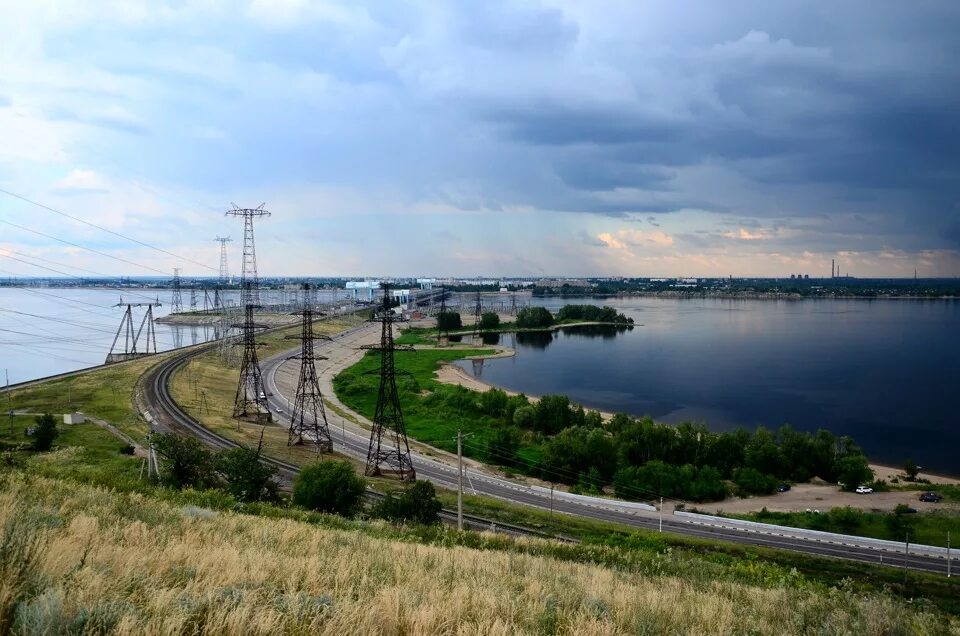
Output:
[287, 283, 333, 453]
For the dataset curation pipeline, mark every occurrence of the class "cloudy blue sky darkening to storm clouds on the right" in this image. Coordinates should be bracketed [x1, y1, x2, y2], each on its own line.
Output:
[0, 0, 960, 277]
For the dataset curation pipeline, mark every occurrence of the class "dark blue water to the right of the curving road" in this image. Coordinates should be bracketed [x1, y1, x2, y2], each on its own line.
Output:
[460, 298, 960, 474]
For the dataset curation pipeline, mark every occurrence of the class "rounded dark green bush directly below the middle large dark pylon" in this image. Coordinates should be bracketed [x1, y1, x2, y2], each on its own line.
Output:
[293, 461, 367, 517]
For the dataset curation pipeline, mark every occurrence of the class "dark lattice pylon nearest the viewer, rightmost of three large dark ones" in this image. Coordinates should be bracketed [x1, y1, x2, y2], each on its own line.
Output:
[363, 285, 417, 480]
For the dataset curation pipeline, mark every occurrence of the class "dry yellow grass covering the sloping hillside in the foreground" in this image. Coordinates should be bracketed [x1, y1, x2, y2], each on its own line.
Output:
[0, 477, 960, 635]
